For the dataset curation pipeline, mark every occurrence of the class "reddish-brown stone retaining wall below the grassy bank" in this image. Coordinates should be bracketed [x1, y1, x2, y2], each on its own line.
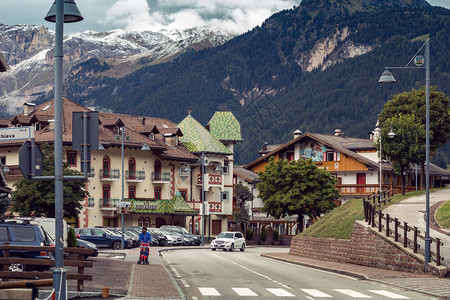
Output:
[289, 221, 447, 277]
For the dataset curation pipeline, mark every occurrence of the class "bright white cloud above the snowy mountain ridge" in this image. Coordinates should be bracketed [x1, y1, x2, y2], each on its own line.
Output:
[100, 0, 298, 33]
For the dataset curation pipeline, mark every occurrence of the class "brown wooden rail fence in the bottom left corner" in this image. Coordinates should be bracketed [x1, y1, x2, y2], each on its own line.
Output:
[0, 243, 93, 292]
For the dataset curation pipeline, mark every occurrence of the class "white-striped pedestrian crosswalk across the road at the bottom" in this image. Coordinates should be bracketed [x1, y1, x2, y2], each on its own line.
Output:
[198, 287, 409, 299]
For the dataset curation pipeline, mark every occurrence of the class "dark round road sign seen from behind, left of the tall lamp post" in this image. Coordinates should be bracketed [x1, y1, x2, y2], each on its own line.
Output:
[19, 141, 44, 179]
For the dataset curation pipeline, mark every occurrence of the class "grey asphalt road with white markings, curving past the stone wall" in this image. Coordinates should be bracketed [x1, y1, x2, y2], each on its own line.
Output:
[164, 247, 435, 300]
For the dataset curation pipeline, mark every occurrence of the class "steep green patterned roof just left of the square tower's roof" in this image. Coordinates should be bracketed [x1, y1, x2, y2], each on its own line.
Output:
[178, 115, 233, 154]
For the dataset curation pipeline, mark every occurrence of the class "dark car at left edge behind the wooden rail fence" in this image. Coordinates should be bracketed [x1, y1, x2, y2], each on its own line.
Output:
[0, 220, 53, 272]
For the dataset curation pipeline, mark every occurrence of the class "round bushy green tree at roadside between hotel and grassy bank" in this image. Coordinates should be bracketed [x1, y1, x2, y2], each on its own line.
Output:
[258, 157, 339, 230]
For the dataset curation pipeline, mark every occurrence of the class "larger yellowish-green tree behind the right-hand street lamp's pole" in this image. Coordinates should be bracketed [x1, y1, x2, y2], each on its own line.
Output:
[378, 86, 450, 188]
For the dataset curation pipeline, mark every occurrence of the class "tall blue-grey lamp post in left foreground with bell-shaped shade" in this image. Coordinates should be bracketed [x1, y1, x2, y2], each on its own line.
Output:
[45, 0, 83, 299]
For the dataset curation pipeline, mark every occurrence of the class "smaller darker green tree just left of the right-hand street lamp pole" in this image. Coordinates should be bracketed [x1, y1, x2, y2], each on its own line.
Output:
[375, 114, 425, 195]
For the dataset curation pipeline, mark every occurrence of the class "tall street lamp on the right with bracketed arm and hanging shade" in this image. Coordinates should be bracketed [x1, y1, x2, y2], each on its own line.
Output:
[378, 39, 431, 272]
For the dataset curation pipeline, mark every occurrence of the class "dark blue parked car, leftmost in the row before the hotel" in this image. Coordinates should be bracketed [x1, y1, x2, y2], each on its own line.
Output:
[75, 228, 128, 250]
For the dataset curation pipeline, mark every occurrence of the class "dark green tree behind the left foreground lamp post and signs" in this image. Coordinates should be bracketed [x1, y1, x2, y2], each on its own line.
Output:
[11, 144, 88, 218]
